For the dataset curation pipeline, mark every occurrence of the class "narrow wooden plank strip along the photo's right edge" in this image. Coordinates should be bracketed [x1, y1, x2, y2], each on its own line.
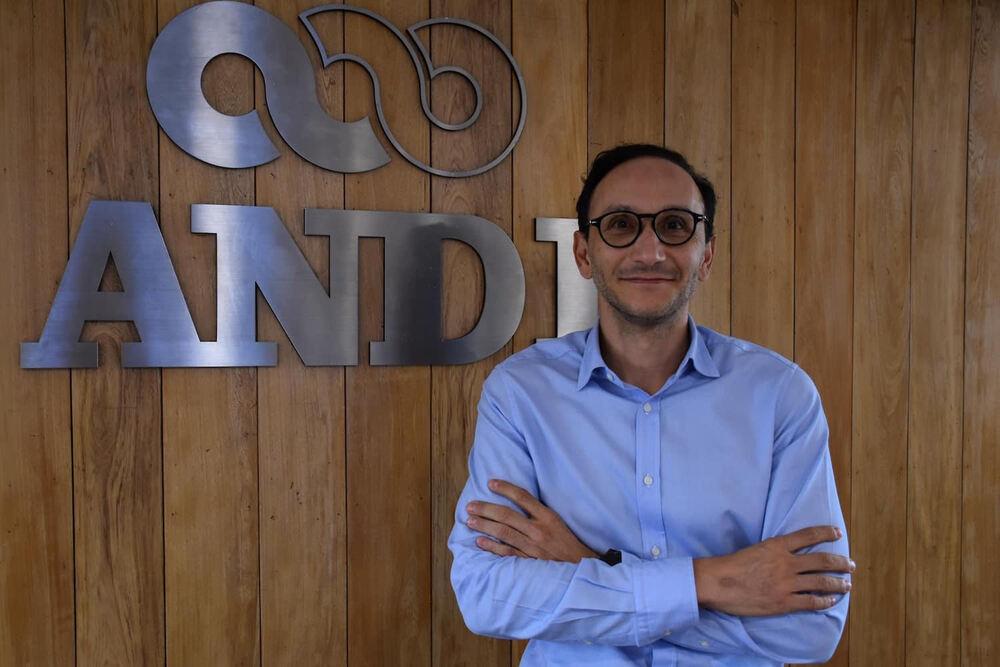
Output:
[962, 0, 1000, 667]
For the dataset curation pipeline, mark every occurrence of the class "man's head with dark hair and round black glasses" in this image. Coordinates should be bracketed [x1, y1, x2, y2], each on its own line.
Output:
[574, 144, 716, 327]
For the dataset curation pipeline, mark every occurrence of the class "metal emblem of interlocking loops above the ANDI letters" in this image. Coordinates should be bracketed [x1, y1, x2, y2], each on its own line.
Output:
[146, 2, 527, 177]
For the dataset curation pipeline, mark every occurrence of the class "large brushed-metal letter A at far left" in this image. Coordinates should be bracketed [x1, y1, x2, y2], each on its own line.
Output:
[21, 201, 199, 368]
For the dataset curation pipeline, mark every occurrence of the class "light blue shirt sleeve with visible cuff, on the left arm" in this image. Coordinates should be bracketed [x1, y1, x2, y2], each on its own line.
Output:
[448, 368, 698, 646]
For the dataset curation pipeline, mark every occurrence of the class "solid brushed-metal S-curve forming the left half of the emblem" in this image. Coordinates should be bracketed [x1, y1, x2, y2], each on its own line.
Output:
[146, 0, 389, 172]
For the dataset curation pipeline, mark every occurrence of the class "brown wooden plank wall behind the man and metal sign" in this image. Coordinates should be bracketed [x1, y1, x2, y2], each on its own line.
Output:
[0, 0, 1000, 667]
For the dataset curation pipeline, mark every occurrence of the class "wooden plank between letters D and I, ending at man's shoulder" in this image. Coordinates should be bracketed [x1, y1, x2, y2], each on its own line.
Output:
[510, 0, 587, 350]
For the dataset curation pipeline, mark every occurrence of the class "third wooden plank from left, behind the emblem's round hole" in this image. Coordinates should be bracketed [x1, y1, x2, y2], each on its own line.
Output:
[158, 0, 260, 665]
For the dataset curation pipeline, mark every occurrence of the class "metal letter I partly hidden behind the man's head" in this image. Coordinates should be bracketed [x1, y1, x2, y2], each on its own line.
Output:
[535, 218, 597, 336]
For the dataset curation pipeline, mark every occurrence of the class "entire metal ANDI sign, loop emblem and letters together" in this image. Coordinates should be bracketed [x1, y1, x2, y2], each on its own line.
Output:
[21, 1, 596, 368]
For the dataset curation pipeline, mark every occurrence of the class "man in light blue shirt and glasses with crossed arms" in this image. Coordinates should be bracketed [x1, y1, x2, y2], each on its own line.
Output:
[449, 145, 854, 667]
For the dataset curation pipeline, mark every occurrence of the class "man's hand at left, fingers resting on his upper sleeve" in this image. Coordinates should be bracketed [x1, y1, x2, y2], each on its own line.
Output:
[466, 479, 597, 563]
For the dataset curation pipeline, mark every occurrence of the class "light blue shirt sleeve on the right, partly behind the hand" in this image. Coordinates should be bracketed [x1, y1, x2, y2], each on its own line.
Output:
[665, 366, 850, 663]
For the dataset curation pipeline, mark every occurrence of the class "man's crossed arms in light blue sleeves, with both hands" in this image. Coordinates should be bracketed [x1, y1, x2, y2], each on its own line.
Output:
[449, 368, 853, 662]
